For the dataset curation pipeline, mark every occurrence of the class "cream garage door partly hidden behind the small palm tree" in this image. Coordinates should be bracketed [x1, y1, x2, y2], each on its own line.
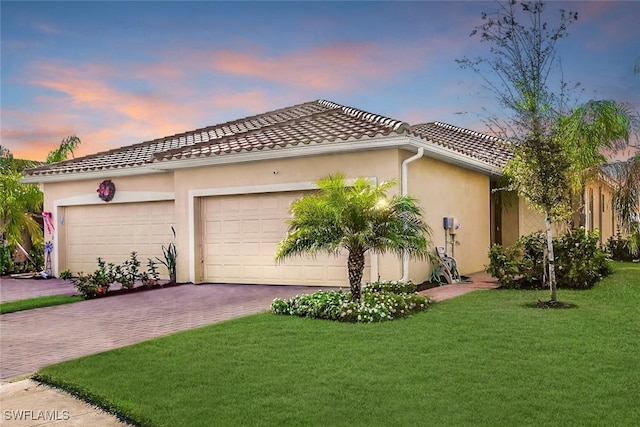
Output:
[202, 192, 370, 286]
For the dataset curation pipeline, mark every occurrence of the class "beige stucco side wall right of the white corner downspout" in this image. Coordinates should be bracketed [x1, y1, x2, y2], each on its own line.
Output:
[403, 154, 490, 283]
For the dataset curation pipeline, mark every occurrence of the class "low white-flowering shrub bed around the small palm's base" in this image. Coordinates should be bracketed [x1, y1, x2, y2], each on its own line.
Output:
[271, 282, 432, 323]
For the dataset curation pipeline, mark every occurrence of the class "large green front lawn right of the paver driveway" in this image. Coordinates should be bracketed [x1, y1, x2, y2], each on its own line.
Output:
[39, 263, 640, 426]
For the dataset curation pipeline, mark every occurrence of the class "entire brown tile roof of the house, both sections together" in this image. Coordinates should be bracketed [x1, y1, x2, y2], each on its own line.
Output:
[24, 100, 508, 178]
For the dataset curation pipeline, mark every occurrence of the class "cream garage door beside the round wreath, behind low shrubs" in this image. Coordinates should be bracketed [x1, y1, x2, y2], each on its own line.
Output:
[61, 201, 175, 275]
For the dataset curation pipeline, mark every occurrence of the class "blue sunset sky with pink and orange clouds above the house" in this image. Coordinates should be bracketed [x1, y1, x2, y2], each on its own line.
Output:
[0, 0, 640, 160]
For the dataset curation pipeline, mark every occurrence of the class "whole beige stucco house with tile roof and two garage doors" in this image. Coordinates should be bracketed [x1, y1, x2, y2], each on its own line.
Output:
[24, 100, 620, 286]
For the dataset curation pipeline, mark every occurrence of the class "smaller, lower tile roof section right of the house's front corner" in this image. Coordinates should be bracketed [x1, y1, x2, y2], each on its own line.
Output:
[410, 122, 513, 168]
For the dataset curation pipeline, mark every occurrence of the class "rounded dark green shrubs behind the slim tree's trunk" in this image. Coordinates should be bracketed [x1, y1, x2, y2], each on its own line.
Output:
[486, 229, 611, 289]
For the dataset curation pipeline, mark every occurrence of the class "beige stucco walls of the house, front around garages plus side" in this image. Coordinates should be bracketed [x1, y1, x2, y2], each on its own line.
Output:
[44, 149, 500, 283]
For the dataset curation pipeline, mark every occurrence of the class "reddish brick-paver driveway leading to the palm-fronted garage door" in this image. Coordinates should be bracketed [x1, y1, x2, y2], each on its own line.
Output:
[0, 284, 317, 381]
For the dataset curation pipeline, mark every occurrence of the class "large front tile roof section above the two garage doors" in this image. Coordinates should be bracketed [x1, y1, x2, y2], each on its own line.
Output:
[24, 100, 409, 177]
